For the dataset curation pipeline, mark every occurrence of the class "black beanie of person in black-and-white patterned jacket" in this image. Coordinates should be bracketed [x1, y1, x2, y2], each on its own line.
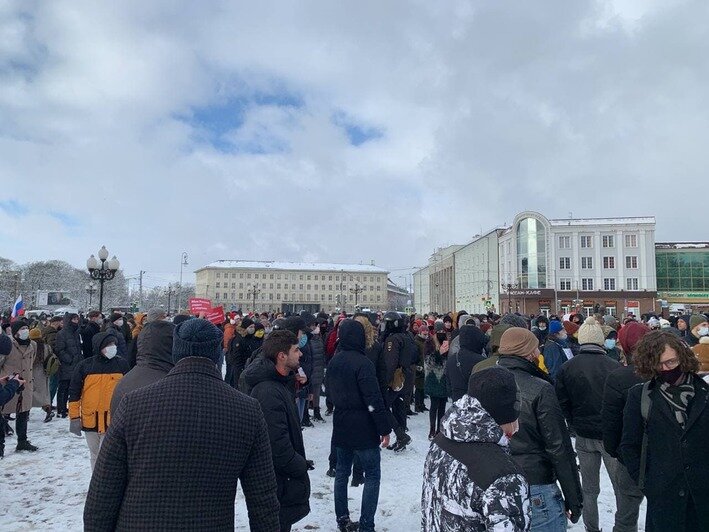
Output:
[468, 366, 519, 425]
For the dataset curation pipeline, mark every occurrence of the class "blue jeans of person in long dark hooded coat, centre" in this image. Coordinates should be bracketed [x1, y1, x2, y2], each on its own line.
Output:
[335, 447, 382, 532]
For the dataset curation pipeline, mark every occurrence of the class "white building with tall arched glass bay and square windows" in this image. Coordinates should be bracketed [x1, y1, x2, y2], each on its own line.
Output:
[499, 212, 657, 315]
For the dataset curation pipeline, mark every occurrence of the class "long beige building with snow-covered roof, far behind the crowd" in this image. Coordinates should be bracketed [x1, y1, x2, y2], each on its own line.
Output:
[195, 260, 388, 312]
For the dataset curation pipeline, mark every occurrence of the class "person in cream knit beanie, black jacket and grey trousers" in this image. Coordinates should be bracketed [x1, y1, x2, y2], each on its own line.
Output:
[556, 317, 620, 532]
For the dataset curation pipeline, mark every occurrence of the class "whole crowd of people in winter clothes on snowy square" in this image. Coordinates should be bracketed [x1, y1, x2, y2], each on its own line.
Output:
[0, 309, 709, 531]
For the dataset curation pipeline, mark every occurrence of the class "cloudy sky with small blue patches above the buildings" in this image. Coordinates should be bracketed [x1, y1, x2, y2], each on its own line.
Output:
[0, 0, 709, 283]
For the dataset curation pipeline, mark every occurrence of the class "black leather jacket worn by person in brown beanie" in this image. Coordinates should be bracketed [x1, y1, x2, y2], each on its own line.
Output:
[497, 355, 583, 515]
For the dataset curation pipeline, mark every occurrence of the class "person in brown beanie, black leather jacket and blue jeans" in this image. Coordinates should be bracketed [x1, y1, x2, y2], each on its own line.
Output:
[498, 327, 583, 532]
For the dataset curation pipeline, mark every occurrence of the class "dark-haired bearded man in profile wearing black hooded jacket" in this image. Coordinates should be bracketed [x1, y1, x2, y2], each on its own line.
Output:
[244, 331, 310, 531]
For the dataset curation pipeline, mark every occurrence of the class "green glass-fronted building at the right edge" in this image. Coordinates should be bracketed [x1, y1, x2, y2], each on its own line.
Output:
[655, 242, 709, 313]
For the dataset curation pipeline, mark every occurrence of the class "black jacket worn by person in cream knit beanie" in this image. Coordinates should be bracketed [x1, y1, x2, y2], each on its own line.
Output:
[556, 344, 620, 440]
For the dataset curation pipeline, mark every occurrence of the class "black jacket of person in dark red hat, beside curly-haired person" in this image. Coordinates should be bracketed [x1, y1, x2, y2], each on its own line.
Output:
[601, 366, 643, 458]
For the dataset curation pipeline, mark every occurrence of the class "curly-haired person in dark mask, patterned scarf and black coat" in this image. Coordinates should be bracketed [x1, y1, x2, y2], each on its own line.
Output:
[620, 331, 709, 531]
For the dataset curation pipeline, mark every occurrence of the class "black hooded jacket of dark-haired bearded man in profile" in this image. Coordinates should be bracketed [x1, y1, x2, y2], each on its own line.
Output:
[244, 356, 310, 525]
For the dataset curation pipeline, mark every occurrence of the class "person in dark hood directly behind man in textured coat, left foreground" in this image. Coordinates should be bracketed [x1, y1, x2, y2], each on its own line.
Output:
[111, 321, 175, 414]
